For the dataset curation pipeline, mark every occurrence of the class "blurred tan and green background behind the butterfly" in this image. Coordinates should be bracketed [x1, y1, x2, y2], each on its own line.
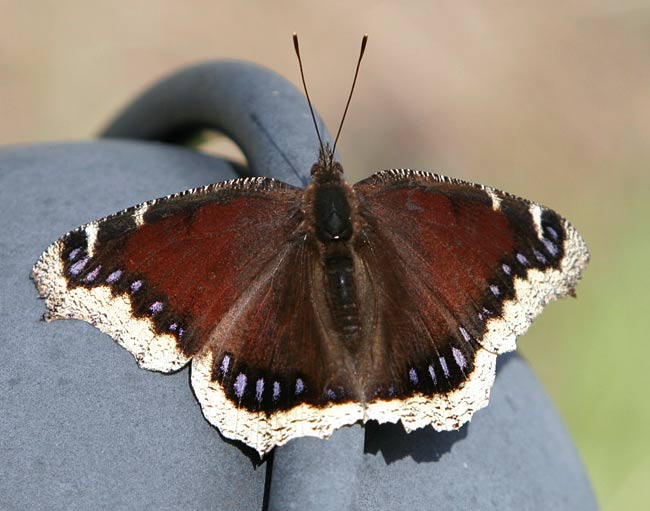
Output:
[0, 0, 650, 510]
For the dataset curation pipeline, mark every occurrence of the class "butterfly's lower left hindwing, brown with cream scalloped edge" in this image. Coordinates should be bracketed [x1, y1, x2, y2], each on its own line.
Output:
[192, 238, 363, 454]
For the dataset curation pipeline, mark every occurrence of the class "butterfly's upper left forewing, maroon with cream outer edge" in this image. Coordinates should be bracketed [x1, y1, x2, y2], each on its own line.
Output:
[33, 178, 301, 372]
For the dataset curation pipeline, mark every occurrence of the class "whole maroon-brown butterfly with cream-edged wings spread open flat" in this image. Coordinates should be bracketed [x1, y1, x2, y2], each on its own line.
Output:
[33, 35, 589, 455]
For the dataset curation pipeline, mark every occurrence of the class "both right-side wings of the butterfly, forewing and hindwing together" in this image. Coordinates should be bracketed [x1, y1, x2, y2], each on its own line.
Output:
[354, 170, 588, 429]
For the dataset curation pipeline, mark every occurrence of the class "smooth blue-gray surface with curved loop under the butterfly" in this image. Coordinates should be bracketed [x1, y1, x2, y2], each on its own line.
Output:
[0, 63, 597, 510]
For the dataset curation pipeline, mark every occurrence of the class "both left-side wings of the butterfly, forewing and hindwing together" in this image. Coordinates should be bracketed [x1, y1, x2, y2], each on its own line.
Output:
[33, 178, 360, 453]
